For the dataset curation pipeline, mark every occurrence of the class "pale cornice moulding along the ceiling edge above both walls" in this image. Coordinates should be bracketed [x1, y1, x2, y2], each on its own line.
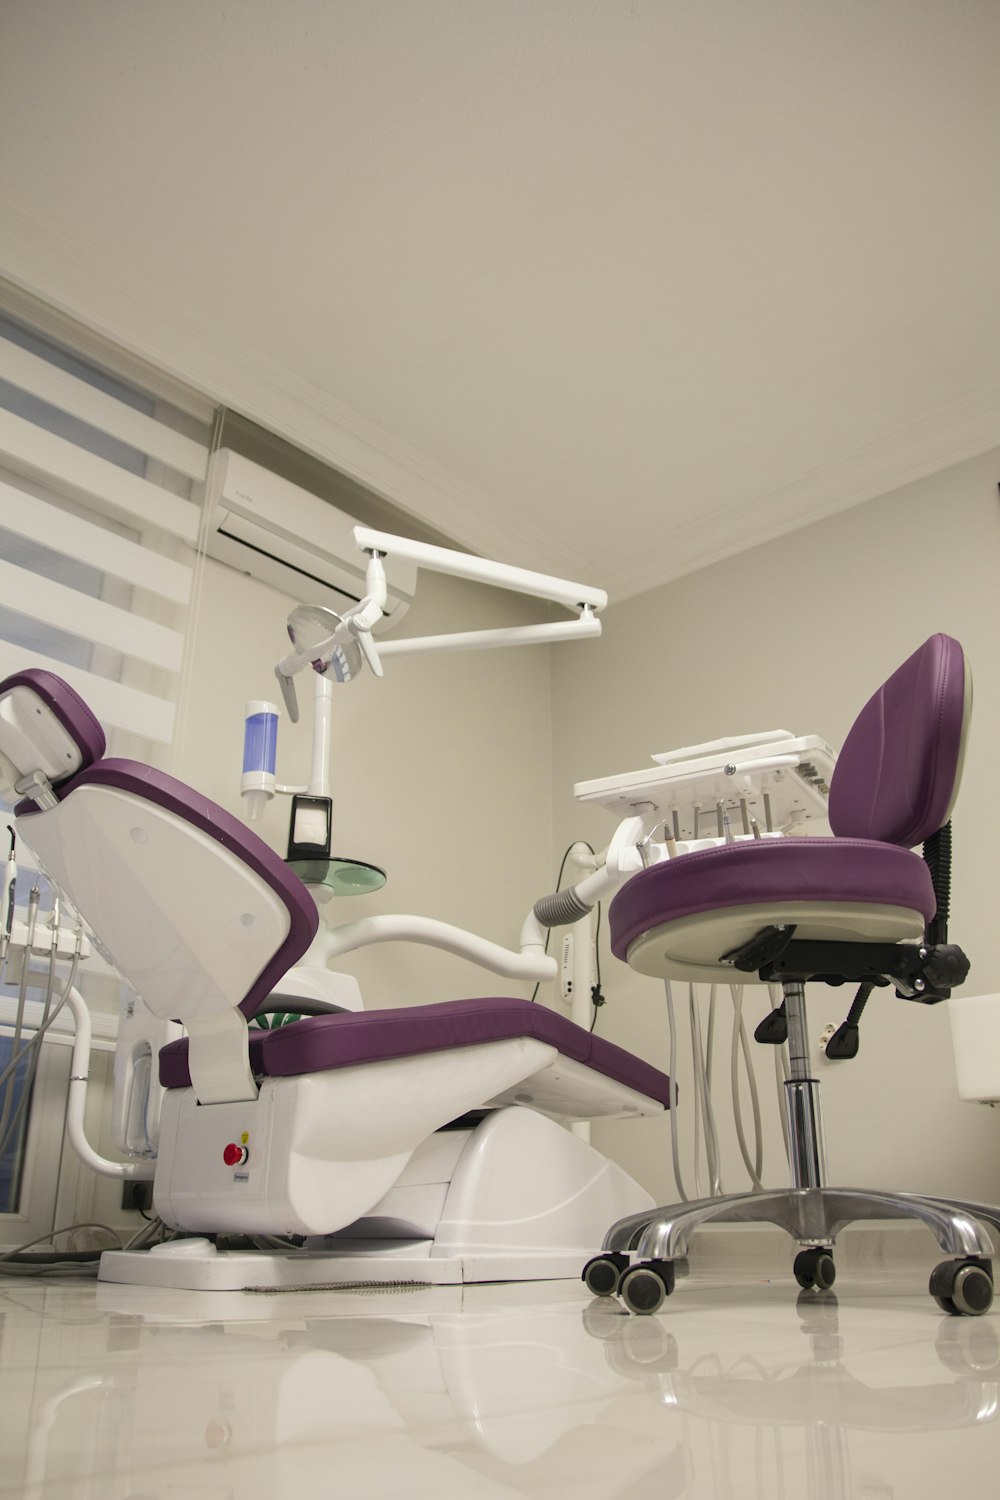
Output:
[0, 207, 1000, 602]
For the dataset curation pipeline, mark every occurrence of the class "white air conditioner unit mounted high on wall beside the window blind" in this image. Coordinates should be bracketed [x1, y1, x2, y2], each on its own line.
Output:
[205, 449, 417, 633]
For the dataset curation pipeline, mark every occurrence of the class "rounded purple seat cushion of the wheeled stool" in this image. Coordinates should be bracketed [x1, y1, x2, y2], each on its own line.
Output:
[607, 839, 937, 962]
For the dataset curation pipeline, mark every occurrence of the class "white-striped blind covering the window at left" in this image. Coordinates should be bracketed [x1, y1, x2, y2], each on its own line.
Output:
[0, 312, 211, 764]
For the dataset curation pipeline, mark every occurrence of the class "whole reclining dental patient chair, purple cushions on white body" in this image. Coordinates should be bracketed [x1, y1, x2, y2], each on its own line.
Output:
[0, 671, 670, 1290]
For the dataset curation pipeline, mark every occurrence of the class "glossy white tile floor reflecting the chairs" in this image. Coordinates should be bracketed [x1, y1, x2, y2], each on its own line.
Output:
[0, 1268, 1000, 1500]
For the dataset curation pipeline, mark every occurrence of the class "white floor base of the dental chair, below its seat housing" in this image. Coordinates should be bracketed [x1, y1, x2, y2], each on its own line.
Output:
[100, 1106, 654, 1290]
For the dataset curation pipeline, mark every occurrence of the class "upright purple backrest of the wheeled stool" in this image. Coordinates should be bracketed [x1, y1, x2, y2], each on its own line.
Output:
[829, 635, 972, 849]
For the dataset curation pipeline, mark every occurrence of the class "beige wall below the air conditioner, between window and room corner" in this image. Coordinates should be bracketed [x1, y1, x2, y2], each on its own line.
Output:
[175, 561, 560, 1008]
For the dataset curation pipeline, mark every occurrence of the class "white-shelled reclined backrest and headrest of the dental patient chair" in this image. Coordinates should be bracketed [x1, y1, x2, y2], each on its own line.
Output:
[0, 671, 318, 1028]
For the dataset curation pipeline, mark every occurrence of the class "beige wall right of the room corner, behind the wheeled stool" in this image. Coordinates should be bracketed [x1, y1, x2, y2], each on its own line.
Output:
[552, 453, 1000, 1202]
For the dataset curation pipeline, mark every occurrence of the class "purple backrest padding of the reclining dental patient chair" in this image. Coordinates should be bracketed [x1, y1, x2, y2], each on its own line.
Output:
[18, 759, 319, 1017]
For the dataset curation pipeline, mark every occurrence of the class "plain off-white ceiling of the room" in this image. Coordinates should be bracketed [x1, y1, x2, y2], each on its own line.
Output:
[0, 0, 1000, 597]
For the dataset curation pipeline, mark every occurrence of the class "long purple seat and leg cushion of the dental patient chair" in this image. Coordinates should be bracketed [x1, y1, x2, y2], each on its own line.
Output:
[160, 999, 670, 1107]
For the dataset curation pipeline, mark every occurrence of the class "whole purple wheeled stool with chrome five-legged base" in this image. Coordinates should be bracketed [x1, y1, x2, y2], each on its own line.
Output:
[583, 635, 1000, 1316]
